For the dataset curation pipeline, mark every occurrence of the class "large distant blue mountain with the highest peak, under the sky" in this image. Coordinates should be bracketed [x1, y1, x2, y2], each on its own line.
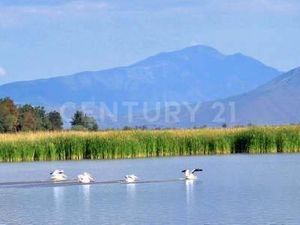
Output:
[0, 46, 280, 112]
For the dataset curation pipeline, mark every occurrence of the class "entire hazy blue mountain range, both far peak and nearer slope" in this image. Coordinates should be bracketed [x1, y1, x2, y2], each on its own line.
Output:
[0, 46, 300, 127]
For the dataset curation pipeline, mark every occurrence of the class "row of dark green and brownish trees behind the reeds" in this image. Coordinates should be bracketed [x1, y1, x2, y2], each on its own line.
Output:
[0, 98, 98, 133]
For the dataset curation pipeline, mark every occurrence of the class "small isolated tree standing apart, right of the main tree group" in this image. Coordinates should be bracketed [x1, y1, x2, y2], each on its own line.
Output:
[71, 111, 98, 131]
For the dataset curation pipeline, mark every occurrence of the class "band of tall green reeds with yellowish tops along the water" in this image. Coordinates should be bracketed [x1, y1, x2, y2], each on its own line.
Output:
[0, 126, 300, 162]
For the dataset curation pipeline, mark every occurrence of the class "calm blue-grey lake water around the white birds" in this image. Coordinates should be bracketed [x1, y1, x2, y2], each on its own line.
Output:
[0, 155, 300, 225]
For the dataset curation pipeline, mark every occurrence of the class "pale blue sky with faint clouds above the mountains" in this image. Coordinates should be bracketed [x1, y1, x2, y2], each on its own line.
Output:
[0, 0, 300, 84]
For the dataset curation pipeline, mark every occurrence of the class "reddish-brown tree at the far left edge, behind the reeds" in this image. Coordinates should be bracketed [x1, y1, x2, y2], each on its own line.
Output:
[0, 98, 18, 132]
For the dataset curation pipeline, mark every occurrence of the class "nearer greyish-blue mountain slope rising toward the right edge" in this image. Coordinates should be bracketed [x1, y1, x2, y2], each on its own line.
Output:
[134, 67, 300, 127]
